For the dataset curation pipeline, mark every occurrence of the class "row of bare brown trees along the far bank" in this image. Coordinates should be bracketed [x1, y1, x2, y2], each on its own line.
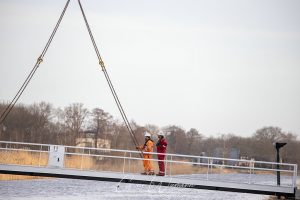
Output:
[0, 102, 300, 165]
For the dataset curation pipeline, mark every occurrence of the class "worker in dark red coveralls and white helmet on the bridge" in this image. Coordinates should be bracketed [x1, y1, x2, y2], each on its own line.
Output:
[156, 131, 168, 176]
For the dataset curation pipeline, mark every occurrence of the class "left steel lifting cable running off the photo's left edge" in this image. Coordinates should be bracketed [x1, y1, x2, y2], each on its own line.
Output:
[0, 0, 70, 124]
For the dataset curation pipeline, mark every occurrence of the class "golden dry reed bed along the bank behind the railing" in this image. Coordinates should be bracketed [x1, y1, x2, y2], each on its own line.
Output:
[0, 150, 278, 180]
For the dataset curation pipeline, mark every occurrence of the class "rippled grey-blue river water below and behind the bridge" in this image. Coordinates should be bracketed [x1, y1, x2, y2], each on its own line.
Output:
[0, 174, 298, 200]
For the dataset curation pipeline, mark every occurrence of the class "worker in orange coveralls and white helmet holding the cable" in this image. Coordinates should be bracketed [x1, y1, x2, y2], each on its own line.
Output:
[136, 131, 154, 175]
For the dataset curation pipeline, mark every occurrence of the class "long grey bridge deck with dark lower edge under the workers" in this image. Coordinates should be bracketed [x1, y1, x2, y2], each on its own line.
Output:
[0, 164, 295, 196]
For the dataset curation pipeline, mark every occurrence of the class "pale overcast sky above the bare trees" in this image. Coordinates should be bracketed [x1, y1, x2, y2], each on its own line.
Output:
[0, 0, 300, 136]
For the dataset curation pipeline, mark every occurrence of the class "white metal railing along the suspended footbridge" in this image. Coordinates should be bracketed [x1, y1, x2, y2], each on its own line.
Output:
[0, 141, 297, 188]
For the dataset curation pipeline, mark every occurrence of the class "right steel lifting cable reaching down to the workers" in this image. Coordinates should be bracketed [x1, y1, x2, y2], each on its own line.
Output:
[78, 0, 143, 155]
